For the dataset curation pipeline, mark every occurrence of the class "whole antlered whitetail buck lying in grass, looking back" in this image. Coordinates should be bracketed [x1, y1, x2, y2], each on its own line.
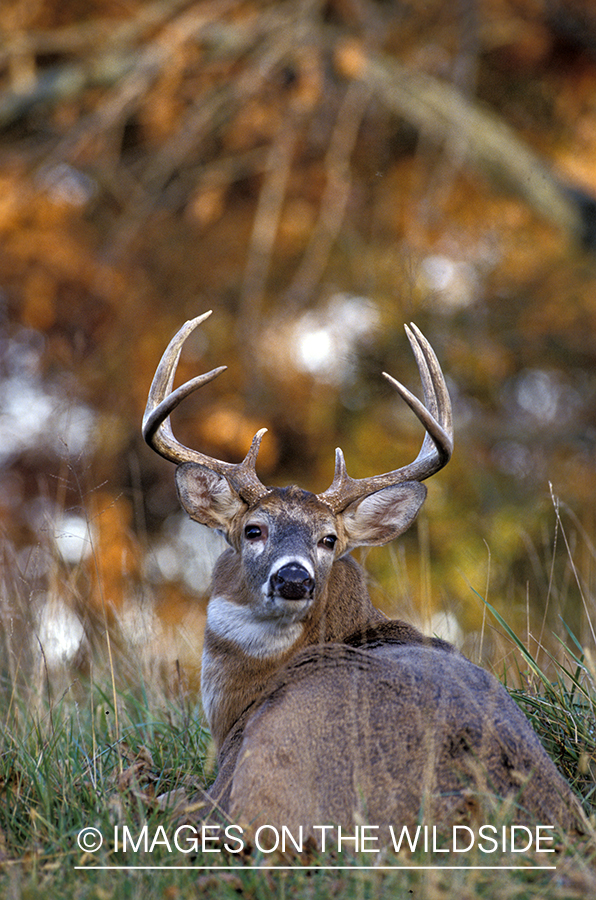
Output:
[143, 313, 581, 833]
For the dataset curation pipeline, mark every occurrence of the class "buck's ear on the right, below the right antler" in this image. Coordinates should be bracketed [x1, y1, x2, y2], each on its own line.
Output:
[342, 481, 426, 550]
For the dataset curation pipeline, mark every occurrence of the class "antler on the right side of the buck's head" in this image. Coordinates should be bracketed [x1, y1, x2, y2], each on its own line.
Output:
[318, 324, 453, 513]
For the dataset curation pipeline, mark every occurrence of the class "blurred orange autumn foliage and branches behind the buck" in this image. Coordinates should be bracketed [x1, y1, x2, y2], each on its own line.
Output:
[0, 0, 596, 683]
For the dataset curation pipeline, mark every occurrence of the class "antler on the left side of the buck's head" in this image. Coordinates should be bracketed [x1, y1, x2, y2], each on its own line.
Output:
[142, 310, 268, 503]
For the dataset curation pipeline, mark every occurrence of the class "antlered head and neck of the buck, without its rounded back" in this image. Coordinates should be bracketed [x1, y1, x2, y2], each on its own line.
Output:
[143, 313, 453, 743]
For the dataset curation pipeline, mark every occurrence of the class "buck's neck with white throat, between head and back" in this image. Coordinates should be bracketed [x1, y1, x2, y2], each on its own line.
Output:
[201, 554, 386, 747]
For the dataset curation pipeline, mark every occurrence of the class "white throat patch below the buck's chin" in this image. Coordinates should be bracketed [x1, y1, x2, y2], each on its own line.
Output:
[207, 596, 309, 659]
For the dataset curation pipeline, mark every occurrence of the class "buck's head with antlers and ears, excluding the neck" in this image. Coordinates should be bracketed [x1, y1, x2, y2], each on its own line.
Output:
[143, 312, 453, 600]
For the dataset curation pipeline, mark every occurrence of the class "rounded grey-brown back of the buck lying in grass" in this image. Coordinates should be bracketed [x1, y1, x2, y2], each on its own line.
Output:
[221, 637, 585, 836]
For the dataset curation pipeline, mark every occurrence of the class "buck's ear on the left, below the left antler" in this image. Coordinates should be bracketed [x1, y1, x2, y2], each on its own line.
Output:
[176, 463, 246, 534]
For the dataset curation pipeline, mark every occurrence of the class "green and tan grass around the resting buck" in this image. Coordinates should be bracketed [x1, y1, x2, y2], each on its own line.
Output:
[0, 510, 596, 900]
